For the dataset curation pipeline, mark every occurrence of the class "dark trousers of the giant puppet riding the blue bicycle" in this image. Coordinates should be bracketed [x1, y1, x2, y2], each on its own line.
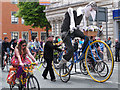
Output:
[62, 29, 89, 61]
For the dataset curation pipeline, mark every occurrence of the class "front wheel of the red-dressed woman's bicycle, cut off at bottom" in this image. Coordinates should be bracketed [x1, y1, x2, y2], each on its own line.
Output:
[27, 75, 40, 90]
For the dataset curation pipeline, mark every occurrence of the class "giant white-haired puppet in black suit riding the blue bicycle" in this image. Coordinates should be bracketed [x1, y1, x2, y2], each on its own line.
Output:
[57, 1, 97, 68]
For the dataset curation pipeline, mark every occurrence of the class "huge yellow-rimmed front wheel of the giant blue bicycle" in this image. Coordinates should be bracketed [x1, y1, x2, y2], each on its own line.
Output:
[85, 40, 114, 82]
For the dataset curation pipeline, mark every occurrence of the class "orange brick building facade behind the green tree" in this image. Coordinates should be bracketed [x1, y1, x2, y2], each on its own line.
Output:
[0, 0, 50, 42]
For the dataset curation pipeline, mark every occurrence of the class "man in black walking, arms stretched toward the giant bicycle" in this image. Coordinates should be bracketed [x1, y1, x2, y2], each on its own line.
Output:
[42, 36, 62, 82]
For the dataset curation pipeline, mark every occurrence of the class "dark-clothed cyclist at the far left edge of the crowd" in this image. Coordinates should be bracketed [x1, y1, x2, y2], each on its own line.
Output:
[1, 37, 10, 70]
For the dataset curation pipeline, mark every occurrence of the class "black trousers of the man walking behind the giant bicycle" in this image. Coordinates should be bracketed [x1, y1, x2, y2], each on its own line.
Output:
[42, 59, 55, 80]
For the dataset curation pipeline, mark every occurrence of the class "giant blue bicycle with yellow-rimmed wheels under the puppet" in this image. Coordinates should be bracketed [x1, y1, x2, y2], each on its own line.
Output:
[53, 40, 114, 82]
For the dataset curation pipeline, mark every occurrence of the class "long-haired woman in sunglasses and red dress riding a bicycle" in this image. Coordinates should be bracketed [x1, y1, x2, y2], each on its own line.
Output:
[11, 39, 37, 84]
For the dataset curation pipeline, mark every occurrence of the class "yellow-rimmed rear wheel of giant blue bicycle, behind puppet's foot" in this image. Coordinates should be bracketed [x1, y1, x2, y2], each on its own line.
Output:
[52, 52, 74, 77]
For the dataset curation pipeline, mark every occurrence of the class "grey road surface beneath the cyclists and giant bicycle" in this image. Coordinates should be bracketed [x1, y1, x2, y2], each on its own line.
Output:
[0, 62, 120, 90]
